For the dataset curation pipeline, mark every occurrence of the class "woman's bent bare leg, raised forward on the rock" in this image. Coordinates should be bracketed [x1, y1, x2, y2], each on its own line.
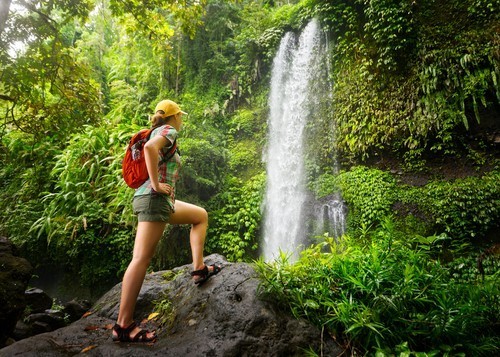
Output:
[168, 200, 208, 270]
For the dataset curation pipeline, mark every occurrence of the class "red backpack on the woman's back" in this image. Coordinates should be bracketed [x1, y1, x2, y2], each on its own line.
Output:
[122, 129, 178, 188]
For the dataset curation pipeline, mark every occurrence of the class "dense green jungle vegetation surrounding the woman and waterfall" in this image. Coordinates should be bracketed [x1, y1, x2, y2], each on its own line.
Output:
[0, 0, 500, 356]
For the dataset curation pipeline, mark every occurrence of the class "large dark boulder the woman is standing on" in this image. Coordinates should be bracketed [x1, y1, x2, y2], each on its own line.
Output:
[0, 255, 343, 357]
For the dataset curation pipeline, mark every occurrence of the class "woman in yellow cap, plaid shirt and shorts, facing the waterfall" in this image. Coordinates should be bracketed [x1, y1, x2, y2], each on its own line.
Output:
[113, 100, 221, 342]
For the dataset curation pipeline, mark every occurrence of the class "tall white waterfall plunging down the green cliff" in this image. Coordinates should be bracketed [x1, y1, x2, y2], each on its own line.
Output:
[262, 20, 346, 260]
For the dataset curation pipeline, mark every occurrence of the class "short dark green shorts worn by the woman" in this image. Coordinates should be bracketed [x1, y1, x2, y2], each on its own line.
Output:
[132, 193, 172, 222]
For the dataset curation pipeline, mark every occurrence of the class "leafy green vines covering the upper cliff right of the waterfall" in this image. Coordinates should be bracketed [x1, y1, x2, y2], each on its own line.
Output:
[300, 0, 500, 165]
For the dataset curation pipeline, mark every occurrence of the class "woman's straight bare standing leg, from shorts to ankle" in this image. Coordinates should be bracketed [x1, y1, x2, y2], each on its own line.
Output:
[117, 218, 166, 338]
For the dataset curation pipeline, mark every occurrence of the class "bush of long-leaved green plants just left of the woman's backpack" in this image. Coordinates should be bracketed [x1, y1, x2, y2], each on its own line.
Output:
[30, 126, 137, 283]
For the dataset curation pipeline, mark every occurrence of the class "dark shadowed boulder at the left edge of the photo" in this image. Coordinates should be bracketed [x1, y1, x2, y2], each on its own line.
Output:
[0, 237, 33, 347]
